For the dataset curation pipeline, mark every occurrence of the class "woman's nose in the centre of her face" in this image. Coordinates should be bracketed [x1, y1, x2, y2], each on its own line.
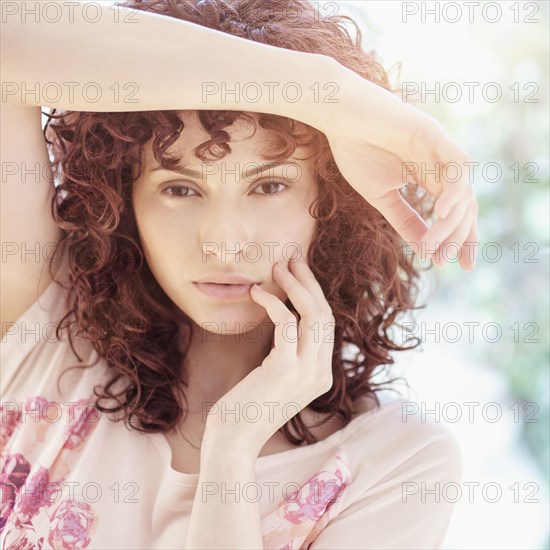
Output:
[199, 197, 255, 262]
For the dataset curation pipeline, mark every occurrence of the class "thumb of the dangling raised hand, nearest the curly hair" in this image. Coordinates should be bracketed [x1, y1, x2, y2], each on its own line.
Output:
[371, 190, 428, 250]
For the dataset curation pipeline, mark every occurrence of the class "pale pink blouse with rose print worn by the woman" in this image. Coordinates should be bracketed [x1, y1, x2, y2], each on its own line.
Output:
[0, 282, 462, 550]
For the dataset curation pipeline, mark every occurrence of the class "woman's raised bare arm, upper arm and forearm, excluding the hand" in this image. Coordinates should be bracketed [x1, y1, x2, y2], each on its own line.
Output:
[0, 1, 343, 336]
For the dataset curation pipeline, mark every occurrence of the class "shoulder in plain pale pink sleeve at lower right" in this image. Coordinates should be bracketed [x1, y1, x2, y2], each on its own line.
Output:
[310, 399, 462, 550]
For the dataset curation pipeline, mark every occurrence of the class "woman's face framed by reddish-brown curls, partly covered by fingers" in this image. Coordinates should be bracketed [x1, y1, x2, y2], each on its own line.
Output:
[133, 111, 316, 334]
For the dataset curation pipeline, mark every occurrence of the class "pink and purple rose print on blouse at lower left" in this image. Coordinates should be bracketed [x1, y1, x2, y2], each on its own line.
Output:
[0, 396, 98, 550]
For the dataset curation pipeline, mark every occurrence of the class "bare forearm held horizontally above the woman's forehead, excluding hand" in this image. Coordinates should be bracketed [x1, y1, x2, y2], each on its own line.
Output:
[1, 2, 341, 124]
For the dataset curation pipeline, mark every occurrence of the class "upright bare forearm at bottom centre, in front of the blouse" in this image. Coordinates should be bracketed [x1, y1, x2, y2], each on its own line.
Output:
[185, 433, 263, 550]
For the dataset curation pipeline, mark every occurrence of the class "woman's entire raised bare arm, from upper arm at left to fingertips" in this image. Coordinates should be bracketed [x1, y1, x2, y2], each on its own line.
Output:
[0, 1, 477, 348]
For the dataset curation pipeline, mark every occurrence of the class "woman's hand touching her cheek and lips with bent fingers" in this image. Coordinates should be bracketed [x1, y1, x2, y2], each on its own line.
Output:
[202, 252, 335, 458]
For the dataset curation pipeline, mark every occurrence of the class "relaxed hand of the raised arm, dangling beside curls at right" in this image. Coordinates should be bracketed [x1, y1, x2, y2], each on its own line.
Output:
[322, 64, 478, 271]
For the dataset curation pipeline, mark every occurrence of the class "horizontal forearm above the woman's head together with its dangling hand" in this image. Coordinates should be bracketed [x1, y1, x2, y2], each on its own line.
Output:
[2, 2, 479, 270]
